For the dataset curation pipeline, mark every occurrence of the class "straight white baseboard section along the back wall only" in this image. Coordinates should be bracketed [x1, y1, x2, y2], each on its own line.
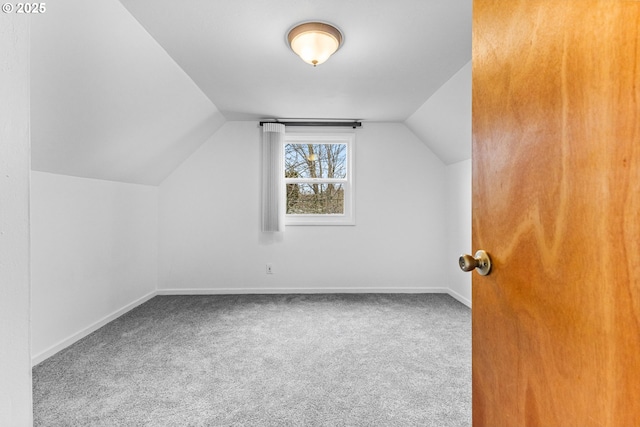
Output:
[158, 287, 449, 295]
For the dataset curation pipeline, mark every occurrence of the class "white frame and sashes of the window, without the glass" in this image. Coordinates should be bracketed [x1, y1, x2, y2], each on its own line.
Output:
[281, 132, 356, 225]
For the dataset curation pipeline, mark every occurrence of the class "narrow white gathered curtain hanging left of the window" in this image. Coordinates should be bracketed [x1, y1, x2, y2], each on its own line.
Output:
[262, 123, 285, 232]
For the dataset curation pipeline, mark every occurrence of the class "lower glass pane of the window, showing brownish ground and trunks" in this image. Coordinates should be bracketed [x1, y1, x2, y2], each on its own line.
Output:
[287, 184, 344, 215]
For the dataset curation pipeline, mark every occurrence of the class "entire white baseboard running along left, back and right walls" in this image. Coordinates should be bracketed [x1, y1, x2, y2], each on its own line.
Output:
[31, 287, 471, 366]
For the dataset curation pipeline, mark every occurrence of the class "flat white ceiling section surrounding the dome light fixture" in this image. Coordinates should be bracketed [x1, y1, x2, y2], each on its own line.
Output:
[121, 0, 471, 121]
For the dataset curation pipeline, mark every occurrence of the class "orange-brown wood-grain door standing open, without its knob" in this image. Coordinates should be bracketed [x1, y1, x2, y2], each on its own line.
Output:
[473, 0, 640, 427]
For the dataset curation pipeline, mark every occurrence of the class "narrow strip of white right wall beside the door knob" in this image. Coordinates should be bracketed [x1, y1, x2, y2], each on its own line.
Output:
[445, 159, 477, 307]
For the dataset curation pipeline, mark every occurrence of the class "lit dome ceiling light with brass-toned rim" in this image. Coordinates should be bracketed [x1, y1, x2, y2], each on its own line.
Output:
[287, 22, 343, 67]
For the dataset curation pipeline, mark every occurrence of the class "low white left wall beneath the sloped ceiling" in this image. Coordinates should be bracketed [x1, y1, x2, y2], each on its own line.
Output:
[31, 171, 158, 363]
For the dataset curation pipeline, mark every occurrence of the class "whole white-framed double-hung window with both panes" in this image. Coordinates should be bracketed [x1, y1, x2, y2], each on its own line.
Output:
[283, 133, 355, 225]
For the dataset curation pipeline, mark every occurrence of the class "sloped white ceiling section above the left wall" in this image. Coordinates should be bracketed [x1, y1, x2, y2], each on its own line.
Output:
[31, 0, 224, 185]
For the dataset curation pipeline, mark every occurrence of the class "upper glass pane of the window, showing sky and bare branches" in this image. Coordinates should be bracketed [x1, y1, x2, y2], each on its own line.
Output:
[284, 144, 347, 178]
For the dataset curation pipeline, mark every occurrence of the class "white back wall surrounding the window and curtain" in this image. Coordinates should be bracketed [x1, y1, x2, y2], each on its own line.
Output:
[159, 122, 446, 293]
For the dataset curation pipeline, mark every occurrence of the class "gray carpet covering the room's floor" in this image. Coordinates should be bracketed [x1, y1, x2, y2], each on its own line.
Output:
[33, 294, 471, 427]
